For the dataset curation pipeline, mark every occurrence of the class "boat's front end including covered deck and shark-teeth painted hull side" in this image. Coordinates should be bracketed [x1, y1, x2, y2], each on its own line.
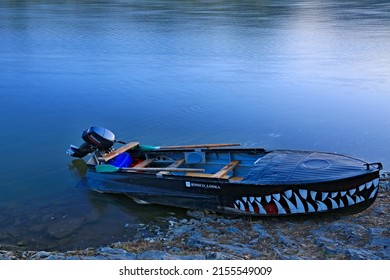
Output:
[232, 151, 382, 215]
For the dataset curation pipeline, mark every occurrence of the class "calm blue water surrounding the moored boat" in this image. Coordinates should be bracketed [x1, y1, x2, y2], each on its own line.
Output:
[0, 0, 390, 249]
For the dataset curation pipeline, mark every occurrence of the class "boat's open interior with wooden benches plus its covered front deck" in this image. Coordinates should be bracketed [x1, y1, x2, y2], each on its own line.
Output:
[90, 143, 378, 184]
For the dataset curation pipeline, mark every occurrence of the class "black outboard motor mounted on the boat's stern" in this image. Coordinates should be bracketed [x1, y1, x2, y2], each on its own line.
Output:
[66, 126, 119, 158]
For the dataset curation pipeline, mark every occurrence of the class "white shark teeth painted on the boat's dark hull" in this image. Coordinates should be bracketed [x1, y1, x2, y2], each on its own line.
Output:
[232, 179, 379, 215]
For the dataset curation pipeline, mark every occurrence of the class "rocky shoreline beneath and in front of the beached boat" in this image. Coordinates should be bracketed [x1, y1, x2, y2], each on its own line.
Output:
[0, 176, 390, 260]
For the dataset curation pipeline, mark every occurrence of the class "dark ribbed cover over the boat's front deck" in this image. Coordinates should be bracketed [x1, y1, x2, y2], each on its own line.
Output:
[244, 151, 382, 184]
